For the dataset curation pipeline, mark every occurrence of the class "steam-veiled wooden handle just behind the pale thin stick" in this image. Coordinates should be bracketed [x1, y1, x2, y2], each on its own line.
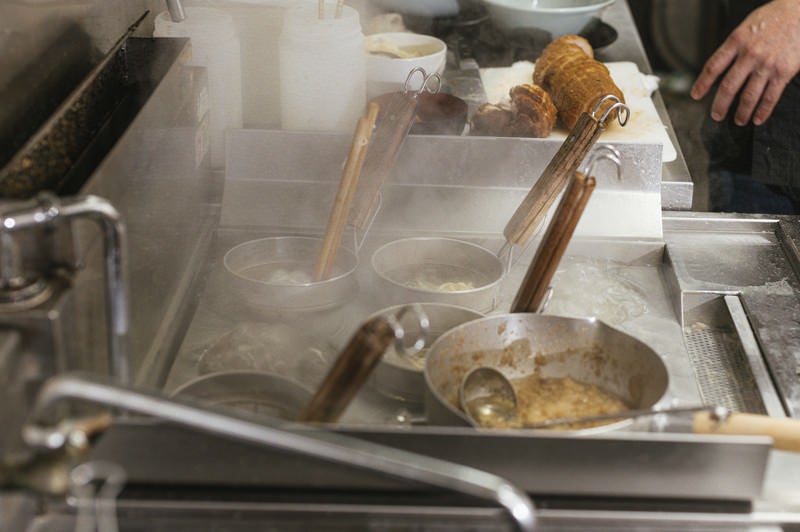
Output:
[349, 92, 417, 229]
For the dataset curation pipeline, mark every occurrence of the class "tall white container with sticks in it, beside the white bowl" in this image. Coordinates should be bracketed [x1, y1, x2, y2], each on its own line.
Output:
[279, 3, 366, 132]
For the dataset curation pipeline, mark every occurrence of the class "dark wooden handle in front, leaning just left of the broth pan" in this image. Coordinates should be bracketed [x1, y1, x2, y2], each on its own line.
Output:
[299, 316, 395, 423]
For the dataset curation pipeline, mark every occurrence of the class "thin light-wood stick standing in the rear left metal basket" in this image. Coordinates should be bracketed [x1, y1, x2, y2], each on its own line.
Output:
[313, 102, 379, 282]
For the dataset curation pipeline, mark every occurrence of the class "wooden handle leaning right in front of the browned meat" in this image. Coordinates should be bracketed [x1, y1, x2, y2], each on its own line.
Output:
[503, 113, 603, 246]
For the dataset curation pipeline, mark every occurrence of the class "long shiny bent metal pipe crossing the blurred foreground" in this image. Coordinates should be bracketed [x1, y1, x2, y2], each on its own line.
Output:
[23, 374, 536, 531]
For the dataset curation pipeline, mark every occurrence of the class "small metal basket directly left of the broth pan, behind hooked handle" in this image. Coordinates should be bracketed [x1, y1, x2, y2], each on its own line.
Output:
[368, 303, 483, 403]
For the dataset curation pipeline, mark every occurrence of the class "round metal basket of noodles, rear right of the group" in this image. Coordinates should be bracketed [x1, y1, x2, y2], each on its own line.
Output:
[372, 237, 505, 313]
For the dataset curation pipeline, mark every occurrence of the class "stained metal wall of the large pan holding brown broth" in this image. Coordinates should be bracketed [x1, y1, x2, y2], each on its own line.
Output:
[425, 314, 669, 433]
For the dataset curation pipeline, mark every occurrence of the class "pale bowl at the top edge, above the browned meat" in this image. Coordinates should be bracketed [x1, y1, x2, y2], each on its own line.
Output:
[484, 0, 614, 39]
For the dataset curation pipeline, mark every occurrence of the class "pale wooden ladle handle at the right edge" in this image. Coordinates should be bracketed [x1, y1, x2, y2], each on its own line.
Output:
[693, 412, 800, 452]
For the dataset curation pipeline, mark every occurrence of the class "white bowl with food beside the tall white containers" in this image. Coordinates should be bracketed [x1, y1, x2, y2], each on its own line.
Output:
[365, 32, 447, 98]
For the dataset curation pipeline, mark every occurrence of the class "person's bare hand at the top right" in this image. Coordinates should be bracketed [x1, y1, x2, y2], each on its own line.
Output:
[691, 0, 800, 126]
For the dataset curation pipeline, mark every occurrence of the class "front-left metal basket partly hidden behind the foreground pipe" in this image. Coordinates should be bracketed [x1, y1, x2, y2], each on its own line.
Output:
[172, 371, 312, 421]
